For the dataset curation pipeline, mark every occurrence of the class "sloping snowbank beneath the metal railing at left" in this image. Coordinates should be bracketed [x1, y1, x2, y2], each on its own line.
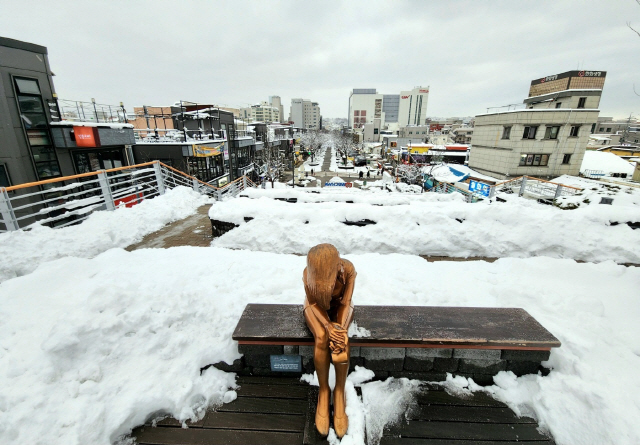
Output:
[0, 187, 211, 282]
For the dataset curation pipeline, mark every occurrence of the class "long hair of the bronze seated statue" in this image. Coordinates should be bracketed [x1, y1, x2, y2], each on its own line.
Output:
[307, 244, 340, 311]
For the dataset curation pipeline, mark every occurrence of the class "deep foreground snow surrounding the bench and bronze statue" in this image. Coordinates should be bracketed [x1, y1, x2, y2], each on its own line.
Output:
[0, 248, 640, 445]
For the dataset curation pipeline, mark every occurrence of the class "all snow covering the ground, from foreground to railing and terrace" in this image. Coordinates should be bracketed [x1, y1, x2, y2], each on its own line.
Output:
[0, 179, 640, 445]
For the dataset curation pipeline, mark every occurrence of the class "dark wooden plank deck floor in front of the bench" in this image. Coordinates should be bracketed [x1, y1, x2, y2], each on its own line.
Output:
[132, 377, 554, 445]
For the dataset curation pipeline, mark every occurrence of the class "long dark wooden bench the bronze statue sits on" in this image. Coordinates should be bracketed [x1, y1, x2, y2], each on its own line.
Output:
[213, 304, 560, 384]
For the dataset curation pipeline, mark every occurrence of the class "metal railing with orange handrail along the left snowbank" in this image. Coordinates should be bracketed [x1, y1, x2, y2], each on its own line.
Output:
[0, 161, 256, 232]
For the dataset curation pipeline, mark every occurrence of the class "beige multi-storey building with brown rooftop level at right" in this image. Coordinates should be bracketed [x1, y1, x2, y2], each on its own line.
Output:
[469, 71, 606, 178]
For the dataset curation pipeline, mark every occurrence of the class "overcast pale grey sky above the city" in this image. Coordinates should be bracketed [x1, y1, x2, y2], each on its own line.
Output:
[0, 0, 640, 118]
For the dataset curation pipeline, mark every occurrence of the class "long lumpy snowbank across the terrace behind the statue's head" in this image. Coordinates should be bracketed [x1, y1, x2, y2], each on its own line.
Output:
[209, 191, 640, 263]
